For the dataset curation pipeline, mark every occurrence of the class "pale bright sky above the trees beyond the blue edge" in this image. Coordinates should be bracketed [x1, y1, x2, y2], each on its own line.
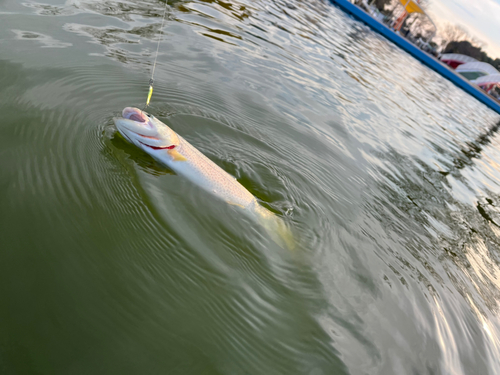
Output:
[428, 0, 500, 58]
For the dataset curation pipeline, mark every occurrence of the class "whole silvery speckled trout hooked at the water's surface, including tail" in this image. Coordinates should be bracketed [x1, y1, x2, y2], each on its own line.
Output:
[114, 107, 294, 249]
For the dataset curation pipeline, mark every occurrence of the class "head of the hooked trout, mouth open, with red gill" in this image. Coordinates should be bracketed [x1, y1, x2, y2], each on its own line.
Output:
[113, 107, 179, 154]
